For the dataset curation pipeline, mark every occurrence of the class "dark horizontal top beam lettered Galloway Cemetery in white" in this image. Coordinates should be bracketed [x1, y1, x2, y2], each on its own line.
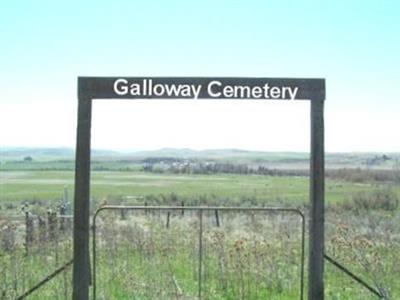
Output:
[78, 77, 325, 101]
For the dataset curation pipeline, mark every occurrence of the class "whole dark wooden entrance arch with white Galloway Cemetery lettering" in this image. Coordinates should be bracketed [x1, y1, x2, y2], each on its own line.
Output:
[73, 77, 325, 300]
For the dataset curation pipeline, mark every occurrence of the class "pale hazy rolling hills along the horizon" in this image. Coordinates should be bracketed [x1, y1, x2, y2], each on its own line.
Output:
[0, 147, 400, 168]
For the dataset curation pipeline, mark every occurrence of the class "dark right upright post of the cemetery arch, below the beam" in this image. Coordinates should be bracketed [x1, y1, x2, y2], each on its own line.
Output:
[308, 99, 325, 300]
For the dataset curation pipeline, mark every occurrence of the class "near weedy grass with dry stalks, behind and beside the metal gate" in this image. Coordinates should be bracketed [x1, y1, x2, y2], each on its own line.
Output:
[0, 212, 400, 300]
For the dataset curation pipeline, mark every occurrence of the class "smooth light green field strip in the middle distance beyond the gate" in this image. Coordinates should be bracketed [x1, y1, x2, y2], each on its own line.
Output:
[0, 171, 394, 205]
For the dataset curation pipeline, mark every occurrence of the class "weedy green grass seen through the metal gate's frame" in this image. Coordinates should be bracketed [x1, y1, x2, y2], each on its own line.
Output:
[97, 213, 306, 300]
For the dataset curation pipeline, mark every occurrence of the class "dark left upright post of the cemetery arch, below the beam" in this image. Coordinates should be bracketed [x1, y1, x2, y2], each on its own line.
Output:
[73, 98, 92, 300]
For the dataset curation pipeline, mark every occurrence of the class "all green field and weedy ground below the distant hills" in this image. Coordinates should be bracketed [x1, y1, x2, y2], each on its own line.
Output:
[0, 151, 400, 299]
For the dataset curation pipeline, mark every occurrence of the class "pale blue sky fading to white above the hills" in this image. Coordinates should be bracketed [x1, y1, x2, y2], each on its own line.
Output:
[0, 0, 400, 152]
